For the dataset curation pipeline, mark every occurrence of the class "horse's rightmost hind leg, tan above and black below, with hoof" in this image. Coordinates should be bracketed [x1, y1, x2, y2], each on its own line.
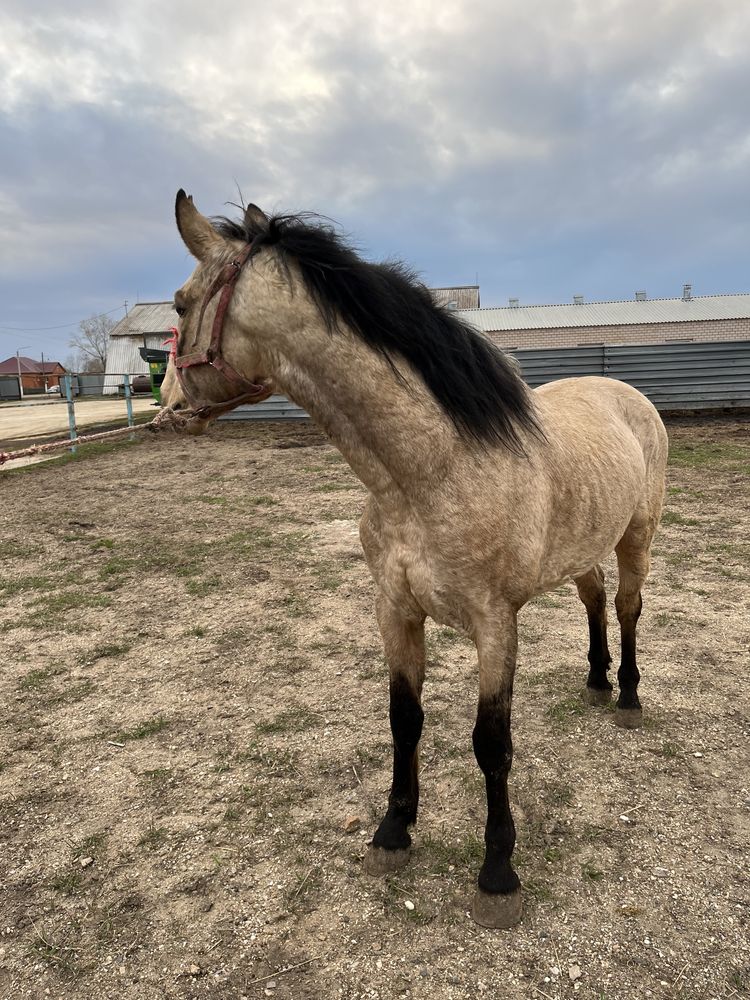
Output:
[615, 522, 653, 729]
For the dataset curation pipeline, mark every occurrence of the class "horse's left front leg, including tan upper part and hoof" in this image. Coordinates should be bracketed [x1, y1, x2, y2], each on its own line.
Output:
[365, 594, 425, 875]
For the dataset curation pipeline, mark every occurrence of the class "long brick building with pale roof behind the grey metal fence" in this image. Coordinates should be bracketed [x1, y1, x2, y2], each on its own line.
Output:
[461, 285, 750, 350]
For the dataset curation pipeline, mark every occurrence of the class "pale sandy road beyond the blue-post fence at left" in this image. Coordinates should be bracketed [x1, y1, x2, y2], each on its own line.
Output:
[0, 395, 156, 451]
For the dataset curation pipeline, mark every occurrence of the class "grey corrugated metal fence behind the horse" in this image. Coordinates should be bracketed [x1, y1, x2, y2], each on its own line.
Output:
[220, 340, 750, 420]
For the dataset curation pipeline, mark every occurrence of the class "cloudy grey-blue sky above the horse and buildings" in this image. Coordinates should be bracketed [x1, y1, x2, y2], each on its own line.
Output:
[0, 0, 750, 361]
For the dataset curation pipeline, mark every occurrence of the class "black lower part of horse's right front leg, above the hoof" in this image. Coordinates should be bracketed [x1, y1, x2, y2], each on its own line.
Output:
[473, 693, 520, 893]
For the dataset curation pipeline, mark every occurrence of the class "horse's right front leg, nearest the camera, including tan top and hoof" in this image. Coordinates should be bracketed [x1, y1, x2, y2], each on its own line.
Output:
[472, 608, 521, 927]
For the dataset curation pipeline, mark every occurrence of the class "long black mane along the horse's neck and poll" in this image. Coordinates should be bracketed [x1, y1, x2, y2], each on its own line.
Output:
[213, 210, 539, 453]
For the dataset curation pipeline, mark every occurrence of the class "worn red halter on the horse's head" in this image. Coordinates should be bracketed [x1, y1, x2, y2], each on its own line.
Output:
[172, 244, 272, 420]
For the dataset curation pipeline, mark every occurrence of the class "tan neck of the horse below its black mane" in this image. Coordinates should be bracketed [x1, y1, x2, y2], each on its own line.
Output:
[276, 329, 456, 515]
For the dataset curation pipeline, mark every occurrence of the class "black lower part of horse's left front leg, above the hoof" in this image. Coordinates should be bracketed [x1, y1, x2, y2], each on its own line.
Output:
[372, 676, 424, 851]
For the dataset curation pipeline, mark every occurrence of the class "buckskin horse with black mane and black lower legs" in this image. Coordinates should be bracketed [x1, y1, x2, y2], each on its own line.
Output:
[161, 190, 667, 928]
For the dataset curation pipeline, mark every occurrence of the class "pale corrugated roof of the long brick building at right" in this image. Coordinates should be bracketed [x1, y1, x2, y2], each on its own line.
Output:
[461, 293, 750, 333]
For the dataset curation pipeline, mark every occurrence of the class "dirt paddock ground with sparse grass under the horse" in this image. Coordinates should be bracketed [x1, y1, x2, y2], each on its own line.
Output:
[0, 419, 750, 1000]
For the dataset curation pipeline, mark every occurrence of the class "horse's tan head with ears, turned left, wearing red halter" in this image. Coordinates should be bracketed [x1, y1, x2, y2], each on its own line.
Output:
[161, 191, 279, 433]
